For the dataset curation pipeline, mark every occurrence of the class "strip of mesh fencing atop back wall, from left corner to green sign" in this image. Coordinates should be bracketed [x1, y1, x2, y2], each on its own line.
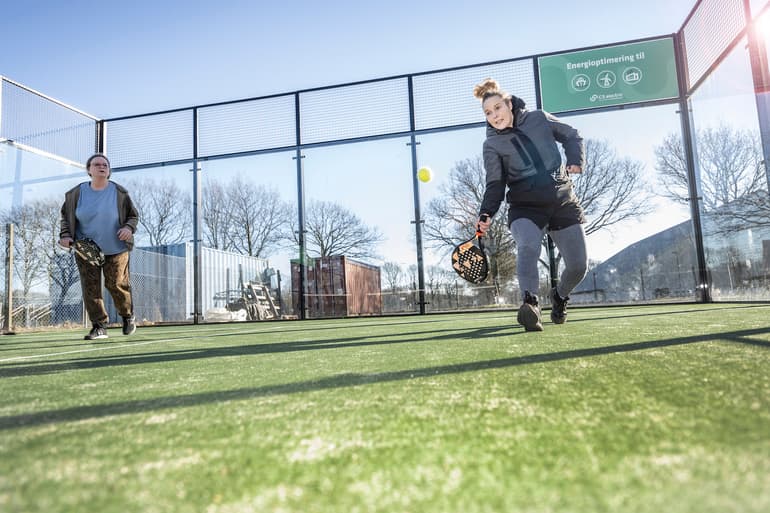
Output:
[105, 58, 537, 168]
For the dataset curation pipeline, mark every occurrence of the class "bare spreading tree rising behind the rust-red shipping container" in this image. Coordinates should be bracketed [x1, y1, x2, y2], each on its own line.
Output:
[291, 201, 385, 258]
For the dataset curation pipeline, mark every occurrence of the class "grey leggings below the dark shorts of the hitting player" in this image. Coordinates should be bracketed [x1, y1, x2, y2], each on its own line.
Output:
[511, 217, 588, 300]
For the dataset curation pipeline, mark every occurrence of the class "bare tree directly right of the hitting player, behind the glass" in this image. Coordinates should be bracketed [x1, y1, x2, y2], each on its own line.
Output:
[572, 139, 652, 235]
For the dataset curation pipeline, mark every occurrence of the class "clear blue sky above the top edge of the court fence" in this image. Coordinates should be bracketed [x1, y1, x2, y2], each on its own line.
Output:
[0, 0, 695, 118]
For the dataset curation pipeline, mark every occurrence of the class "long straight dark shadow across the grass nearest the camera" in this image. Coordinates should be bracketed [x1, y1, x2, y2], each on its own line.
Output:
[0, 327, 770, 430]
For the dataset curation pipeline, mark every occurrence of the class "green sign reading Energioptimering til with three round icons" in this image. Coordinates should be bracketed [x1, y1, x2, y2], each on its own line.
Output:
[538, 38, 679, 112]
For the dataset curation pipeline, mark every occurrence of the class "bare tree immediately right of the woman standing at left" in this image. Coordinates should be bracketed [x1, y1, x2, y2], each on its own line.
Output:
[125, 178, 192, 246]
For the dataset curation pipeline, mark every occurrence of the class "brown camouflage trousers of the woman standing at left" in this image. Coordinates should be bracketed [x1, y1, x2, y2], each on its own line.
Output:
[75, 251, 134, 324]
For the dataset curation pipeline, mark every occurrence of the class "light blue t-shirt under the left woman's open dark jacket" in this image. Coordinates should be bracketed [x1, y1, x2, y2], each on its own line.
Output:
[75, 182, 128, 255]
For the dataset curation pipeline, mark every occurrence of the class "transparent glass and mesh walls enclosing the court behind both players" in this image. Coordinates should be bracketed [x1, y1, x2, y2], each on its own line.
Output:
[0, 0, 770, 326]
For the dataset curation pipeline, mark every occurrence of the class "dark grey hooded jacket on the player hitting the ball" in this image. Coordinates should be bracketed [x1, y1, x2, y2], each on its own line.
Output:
[479, 96, 585, 215]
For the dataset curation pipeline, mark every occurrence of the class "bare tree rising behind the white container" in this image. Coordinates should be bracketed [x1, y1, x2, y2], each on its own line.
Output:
[224, 177, 291, 258]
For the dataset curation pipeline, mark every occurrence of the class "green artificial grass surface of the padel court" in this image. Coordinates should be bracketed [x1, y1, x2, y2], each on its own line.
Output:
[0, 304, 770, 513]
